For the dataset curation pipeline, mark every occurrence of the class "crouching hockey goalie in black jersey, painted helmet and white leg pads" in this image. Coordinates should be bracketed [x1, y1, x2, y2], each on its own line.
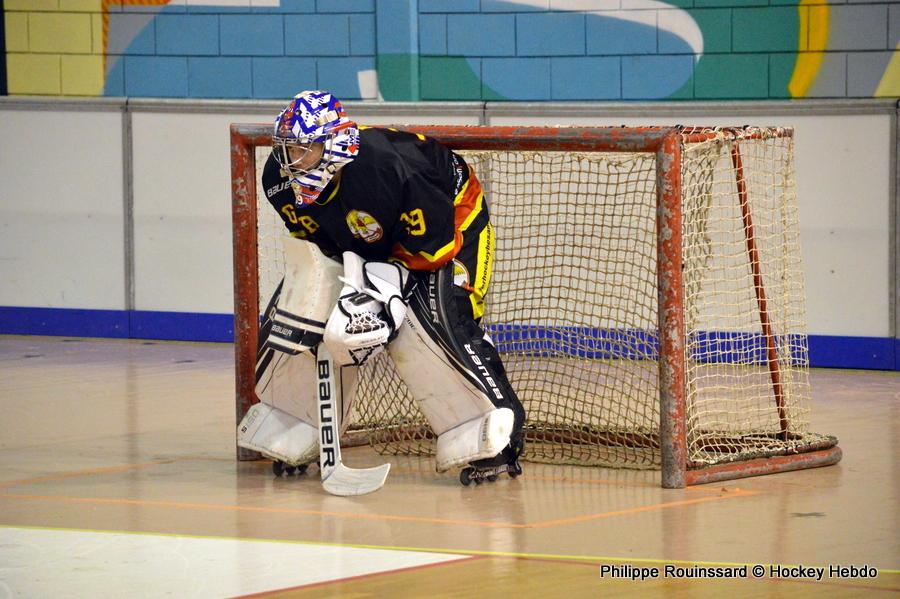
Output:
[238, 91, 525, 484]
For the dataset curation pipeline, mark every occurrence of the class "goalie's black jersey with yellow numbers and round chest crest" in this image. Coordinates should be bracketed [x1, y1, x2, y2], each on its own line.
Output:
[262, 127, 489, 270]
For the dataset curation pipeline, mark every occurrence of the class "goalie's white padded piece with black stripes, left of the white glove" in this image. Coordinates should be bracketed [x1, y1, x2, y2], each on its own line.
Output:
[267, 237, 341, 354]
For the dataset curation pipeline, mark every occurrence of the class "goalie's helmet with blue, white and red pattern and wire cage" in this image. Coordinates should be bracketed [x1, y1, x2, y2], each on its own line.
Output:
[272, 91, 359, 206]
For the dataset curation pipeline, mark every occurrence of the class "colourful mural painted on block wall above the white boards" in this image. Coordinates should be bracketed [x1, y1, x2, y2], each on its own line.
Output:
[3, 0, 900, 101]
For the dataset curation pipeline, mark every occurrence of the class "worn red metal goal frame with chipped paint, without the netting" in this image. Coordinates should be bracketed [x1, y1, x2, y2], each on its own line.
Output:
[231, 124, 842, 488]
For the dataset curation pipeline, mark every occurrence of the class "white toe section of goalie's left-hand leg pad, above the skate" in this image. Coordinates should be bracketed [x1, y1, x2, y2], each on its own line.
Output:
[237, 403, 319, 466]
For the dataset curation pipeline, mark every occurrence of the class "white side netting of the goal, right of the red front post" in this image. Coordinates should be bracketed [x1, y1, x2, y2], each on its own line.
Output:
[682, 132, 821, 464]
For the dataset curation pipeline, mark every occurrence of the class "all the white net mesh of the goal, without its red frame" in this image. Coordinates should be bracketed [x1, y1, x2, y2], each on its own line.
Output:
[250, 130, 825, 468]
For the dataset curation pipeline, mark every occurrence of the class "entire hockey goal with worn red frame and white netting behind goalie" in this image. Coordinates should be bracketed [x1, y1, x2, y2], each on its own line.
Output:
[231, 125, 841, 488]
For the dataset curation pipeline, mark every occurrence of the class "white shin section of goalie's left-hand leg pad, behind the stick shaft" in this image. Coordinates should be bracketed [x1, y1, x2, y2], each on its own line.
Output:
[256, 348, 359, 430]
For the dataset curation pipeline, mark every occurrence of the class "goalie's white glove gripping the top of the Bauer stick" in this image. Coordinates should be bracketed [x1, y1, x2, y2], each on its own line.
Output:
[325, 252, 411, 366]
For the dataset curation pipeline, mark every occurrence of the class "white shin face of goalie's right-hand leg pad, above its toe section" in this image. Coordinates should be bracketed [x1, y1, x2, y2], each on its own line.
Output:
[388, 310, 495, 435]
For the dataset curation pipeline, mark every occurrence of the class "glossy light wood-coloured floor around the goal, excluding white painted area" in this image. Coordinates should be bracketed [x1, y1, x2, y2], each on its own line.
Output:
[0, 337, 900, 598]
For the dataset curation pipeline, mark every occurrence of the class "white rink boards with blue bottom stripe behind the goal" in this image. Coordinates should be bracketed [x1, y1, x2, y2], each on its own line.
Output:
[0, 97, 900, 369]
